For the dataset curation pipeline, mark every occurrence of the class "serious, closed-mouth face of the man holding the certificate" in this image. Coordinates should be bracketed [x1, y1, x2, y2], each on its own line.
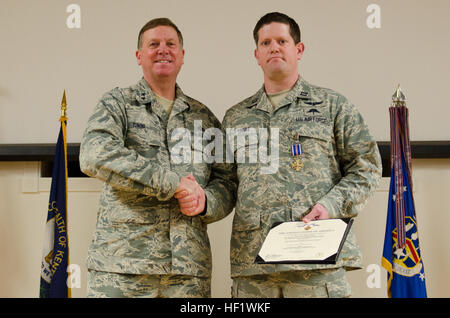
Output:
[255, 22, 304, 80]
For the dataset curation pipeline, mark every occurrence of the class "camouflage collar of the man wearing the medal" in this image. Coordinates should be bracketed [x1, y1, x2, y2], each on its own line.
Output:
[247, 76, 318, 112]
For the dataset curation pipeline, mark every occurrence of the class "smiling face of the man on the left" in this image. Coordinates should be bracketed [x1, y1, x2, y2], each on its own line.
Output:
[136, 26, 184, 82]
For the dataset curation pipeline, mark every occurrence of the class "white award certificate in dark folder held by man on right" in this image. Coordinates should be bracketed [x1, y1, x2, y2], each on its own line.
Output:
[255, 218, 353, 264]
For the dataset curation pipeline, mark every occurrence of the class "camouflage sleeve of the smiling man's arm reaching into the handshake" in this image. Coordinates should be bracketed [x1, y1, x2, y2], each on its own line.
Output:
[80, 89, 180, 201]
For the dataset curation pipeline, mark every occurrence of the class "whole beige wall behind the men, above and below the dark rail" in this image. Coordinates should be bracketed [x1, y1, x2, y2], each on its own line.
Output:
[0, 0, 450, 297]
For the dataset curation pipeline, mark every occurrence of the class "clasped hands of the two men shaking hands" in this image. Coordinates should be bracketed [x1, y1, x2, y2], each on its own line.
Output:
[174, 174, 206, 216]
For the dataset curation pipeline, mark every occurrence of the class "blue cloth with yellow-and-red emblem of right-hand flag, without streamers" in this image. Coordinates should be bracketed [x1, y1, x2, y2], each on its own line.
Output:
[382, 152, 427, 298]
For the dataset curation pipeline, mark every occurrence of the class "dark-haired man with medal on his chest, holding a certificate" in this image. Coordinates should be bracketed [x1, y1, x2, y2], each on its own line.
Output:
[222, 13, 381, 297]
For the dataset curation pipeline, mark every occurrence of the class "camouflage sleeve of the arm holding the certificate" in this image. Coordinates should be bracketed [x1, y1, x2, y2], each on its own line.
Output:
[318, 96, 382, 218]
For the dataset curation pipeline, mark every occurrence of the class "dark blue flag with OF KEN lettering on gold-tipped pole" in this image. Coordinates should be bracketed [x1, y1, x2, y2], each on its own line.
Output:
[39, 92, 71, 298]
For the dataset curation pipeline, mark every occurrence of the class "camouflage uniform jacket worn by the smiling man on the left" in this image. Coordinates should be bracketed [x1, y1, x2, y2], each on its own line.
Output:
[80, 78, 236, 277]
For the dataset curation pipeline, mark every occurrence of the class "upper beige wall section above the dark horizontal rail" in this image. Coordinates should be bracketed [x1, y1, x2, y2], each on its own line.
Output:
[0, 0, 450, 143]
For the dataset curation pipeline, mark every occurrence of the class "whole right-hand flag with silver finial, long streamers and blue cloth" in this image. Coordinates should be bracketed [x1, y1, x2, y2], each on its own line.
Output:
[381, 88, 427, 298]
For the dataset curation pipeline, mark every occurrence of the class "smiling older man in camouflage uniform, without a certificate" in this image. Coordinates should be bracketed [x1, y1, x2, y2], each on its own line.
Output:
[80, 18, 236, 297]
